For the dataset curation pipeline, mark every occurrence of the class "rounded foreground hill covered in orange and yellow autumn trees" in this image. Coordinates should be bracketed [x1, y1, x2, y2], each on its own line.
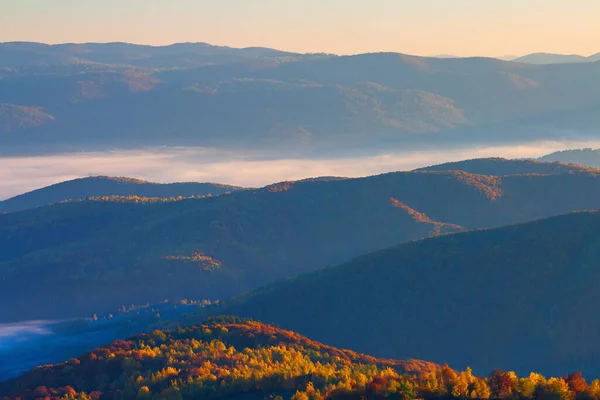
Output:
[0, 318, 440, 399]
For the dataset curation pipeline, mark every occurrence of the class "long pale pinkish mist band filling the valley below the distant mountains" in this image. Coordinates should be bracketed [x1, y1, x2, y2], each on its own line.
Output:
[0, 141, 600, 200]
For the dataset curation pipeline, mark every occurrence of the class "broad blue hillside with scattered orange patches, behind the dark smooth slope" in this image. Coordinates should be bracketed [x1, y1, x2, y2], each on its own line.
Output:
[0, 162, 600, 321]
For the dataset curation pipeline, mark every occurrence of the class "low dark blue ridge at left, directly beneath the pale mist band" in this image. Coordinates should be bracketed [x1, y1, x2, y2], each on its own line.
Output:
[0, 176, 242, 212]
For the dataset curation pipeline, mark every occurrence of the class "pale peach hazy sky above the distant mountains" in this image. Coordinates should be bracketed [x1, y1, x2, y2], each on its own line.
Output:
[0, 0, 600, 56]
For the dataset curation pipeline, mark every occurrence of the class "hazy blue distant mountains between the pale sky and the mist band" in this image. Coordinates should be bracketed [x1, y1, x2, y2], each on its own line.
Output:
[0, 43, 600, 154]
